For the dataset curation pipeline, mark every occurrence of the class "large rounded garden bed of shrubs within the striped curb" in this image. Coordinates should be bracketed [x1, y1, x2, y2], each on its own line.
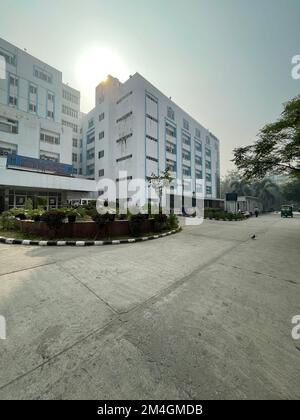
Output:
[0, 202, 178, 244]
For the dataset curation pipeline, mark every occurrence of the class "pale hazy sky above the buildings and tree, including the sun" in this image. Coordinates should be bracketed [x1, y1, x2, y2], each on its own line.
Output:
[0, 0, 300, 175]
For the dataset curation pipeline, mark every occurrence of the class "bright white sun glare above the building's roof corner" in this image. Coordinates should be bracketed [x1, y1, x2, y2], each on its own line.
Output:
[76, 47, 129, 107]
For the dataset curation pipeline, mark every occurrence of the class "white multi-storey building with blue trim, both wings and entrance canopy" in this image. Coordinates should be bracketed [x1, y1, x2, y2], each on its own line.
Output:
[0, 39, 220, 211]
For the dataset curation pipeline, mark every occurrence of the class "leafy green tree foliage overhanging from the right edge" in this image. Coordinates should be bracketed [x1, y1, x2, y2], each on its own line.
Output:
[233, 96, 300, 179]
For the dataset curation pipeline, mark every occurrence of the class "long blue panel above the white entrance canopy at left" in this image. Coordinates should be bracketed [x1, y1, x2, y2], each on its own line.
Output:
[6, 154, 73, 176]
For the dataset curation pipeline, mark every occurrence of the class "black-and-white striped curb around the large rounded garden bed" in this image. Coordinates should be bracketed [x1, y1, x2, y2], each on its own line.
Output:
[0, 228, 181, 246]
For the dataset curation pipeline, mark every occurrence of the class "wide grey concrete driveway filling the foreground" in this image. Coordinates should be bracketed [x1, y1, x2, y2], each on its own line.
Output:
[0, 215, 300, 399]
